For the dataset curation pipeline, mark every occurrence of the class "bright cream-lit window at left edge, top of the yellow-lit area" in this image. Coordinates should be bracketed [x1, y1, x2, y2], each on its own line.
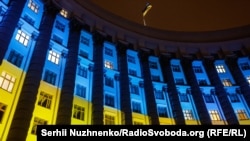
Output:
[0, 71, 16, 92]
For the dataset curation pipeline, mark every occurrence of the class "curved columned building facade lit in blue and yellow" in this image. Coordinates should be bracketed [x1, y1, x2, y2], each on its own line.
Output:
[0, 0, 250, 141]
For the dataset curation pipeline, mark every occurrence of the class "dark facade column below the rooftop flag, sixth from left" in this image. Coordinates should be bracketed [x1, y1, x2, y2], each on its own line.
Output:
[139, 51, 160, 125]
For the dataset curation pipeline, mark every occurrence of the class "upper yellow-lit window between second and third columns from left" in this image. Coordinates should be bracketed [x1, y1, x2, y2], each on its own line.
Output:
[38, 92, 52, 109]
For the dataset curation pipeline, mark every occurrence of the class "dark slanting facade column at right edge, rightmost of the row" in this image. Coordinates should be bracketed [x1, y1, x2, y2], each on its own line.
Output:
[225, 57, 250, 107]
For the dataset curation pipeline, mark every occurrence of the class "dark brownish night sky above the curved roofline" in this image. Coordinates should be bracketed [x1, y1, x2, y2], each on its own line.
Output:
[91, 0, 250, 31]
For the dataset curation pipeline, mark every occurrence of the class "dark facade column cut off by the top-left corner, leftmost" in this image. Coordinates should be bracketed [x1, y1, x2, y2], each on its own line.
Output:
[0, 0, 26, 65]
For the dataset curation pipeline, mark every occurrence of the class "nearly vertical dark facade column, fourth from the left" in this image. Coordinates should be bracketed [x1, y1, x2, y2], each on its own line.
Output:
[92, 31, 105, 125]
